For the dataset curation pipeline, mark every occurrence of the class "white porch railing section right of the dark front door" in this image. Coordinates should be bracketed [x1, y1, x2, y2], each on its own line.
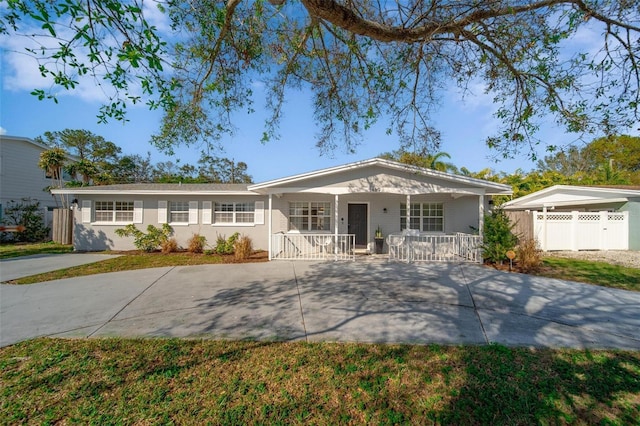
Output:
[387, 230, 482, 263]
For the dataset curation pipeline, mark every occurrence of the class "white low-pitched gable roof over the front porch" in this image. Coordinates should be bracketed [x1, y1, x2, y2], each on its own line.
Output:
[247, 158, 513, 197]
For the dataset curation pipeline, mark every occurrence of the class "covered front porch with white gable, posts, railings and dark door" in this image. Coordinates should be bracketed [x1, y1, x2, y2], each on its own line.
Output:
[245, 159, 510, 262]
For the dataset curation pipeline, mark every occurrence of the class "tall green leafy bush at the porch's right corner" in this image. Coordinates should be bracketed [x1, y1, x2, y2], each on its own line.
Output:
[482, 209, 517, 264]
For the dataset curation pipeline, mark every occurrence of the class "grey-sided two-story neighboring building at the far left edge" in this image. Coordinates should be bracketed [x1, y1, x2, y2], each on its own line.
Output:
[0, 135, 70, 217]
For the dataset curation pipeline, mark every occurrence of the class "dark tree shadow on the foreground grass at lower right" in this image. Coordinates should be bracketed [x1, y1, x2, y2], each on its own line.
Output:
[440, 345, 640, 424]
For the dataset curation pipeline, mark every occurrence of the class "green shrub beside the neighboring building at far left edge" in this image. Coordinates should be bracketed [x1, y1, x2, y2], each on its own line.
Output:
[0, 198, 49, 243]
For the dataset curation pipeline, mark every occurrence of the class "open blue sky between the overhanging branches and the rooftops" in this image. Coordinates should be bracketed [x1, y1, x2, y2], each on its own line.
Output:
[0, 6, 635, 182]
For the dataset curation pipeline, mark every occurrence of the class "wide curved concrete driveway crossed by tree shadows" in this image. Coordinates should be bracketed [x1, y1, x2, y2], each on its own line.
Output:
[0, 262, 640, 350]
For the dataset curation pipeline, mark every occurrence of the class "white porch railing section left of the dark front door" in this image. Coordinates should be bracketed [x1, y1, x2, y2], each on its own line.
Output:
[271, 233, 356, 260]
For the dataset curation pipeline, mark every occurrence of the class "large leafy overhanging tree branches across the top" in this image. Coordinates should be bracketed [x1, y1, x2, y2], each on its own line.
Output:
[1, 0, 640, 155]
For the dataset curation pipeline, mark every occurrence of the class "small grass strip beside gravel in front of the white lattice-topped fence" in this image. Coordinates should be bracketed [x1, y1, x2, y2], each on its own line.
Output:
[536, 257, 640, 291]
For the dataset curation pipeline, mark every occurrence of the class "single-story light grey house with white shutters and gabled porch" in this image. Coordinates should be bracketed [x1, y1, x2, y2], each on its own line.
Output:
[53, 158, 512, 260]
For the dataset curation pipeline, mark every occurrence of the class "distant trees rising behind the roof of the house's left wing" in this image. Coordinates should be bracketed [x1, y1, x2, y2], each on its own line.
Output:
[35, 129, 252, 186]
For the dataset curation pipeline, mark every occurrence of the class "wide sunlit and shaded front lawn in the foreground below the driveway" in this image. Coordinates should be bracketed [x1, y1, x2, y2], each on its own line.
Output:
[0, 339, 640, 425]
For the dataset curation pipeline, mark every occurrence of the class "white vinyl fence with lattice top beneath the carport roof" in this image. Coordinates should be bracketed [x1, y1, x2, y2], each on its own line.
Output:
[533, 211, 629, 251]
